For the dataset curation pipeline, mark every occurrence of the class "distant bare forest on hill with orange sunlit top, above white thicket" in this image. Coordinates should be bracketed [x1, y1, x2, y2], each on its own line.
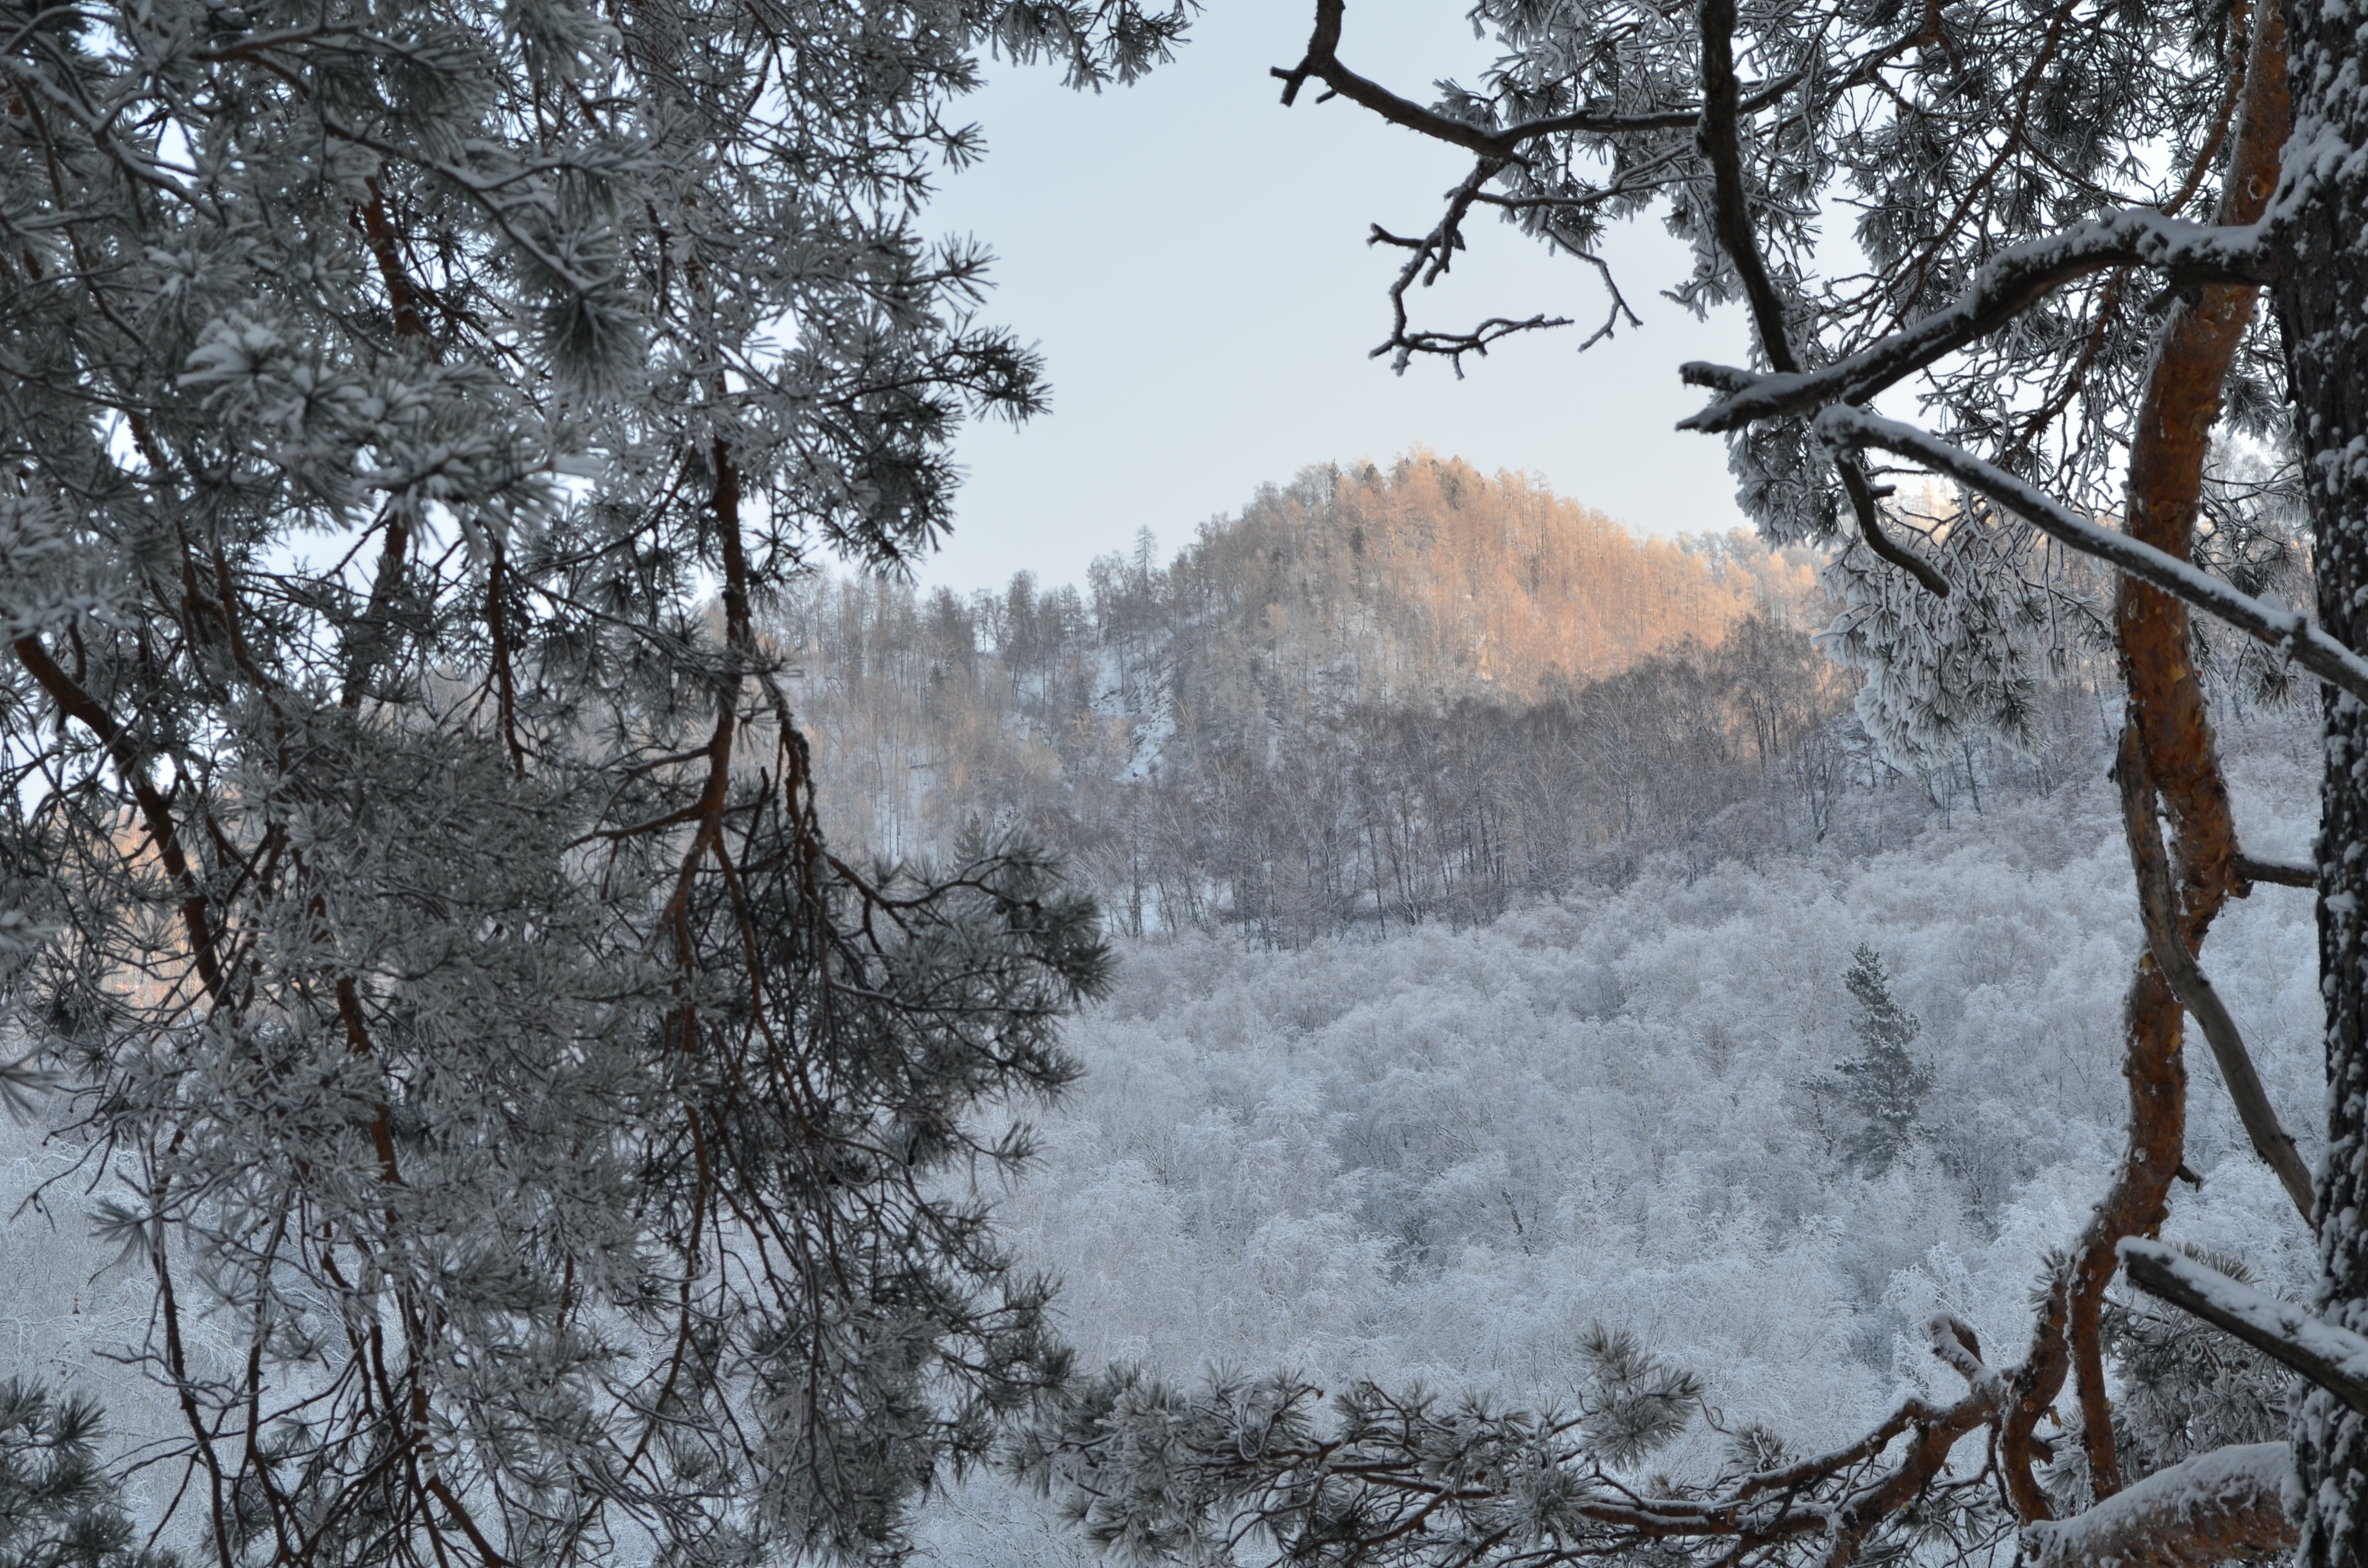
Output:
[772, 455, 2131, 945]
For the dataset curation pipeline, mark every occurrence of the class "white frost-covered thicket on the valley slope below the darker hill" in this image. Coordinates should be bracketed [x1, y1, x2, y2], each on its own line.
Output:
[904, 715, 2320, 1566]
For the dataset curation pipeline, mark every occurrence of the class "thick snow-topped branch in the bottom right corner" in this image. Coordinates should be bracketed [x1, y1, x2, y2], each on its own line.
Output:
[2023, 1443, 2294, 1568]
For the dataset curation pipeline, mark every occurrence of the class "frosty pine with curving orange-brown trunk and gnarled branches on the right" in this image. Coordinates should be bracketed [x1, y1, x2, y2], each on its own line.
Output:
[1013, 0, 2368, 1568]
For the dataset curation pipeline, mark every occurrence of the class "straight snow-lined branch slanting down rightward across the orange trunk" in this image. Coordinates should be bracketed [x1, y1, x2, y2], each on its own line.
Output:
[1816, 405, 2368, 701]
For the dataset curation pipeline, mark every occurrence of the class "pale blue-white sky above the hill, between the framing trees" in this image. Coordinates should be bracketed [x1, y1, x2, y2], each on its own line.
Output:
[924, 0, 1745, 590]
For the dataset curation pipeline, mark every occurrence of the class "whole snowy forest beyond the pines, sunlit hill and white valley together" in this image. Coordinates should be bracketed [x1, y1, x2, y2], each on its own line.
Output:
[5, 455, 2319, 1568]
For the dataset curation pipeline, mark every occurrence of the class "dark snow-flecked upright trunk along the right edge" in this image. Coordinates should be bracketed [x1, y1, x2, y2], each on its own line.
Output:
[2278, 0, 2368, 1568]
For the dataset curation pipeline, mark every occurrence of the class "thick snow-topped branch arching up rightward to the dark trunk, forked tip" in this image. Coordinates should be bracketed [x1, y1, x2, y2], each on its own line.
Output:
[1677, 208, 2269, 431]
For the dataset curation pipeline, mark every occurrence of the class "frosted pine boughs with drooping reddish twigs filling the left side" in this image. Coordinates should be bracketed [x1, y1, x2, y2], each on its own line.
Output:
[0, 0, 1182, 1568]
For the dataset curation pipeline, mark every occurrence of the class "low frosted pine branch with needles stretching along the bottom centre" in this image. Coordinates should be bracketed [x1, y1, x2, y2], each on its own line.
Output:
[1011, 1331, 2003, 1568]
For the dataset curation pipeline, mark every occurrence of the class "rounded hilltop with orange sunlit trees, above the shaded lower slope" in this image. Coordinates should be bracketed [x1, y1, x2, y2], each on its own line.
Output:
[1085, 455, 1812, 706]
